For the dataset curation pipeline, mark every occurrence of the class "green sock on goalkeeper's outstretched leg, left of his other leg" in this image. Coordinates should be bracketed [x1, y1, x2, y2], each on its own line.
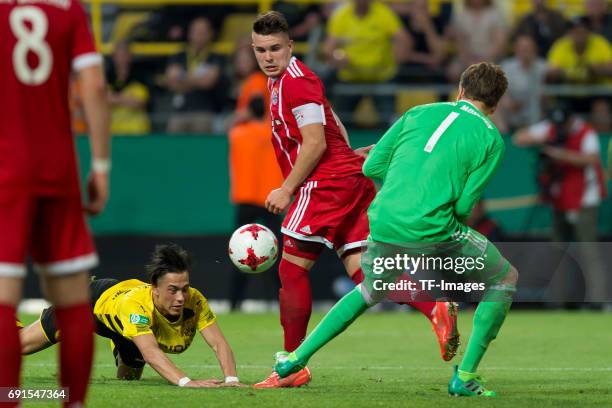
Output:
[289, 286, 368, 364]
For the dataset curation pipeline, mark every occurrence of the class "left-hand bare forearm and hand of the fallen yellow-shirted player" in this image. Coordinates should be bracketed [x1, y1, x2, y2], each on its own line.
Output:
[133, 333, 219, 387]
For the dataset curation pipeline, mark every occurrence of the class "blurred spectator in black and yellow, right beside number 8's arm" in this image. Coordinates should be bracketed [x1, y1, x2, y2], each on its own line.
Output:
[107, 42, 151, 135]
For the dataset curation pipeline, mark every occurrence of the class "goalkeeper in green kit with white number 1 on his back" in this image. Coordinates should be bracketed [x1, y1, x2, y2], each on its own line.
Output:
[274, 63, 518, 396]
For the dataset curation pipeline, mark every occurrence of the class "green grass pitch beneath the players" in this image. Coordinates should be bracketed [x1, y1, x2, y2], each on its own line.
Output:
[23, 311, 612, 408]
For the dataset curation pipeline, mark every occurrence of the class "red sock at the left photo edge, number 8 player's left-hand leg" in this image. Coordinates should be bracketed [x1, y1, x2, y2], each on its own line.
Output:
[0, 304, 21, 396]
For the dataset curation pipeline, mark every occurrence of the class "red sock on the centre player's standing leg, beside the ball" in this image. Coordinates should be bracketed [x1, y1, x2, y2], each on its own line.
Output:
[278, 258, 312, 352]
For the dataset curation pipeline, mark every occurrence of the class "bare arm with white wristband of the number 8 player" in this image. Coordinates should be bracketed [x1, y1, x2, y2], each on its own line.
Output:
[78, 65, 110, 215]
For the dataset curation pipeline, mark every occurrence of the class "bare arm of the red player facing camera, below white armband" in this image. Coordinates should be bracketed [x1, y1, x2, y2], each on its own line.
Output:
[266, 123, 327, 214]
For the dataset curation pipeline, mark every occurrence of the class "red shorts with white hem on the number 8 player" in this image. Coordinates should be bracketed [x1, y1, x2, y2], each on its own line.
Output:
[0, 192, 98, 277]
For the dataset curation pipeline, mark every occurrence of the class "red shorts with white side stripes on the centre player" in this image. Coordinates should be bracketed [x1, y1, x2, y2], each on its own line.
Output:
[281, 174, 376, 256]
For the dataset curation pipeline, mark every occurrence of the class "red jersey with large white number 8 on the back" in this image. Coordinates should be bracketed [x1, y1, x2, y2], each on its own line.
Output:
[0, 0, 102, 195]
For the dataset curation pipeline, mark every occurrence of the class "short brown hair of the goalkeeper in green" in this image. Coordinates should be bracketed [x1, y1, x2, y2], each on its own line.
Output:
[459, 62, 508, 109]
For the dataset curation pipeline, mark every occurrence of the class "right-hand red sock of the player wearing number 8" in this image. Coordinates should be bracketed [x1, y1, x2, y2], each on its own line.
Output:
[55, 303, 94, 406]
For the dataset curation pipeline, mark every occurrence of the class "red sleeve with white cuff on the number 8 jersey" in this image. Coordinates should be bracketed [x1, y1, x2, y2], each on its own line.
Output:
[70, 0, 102, 71]
